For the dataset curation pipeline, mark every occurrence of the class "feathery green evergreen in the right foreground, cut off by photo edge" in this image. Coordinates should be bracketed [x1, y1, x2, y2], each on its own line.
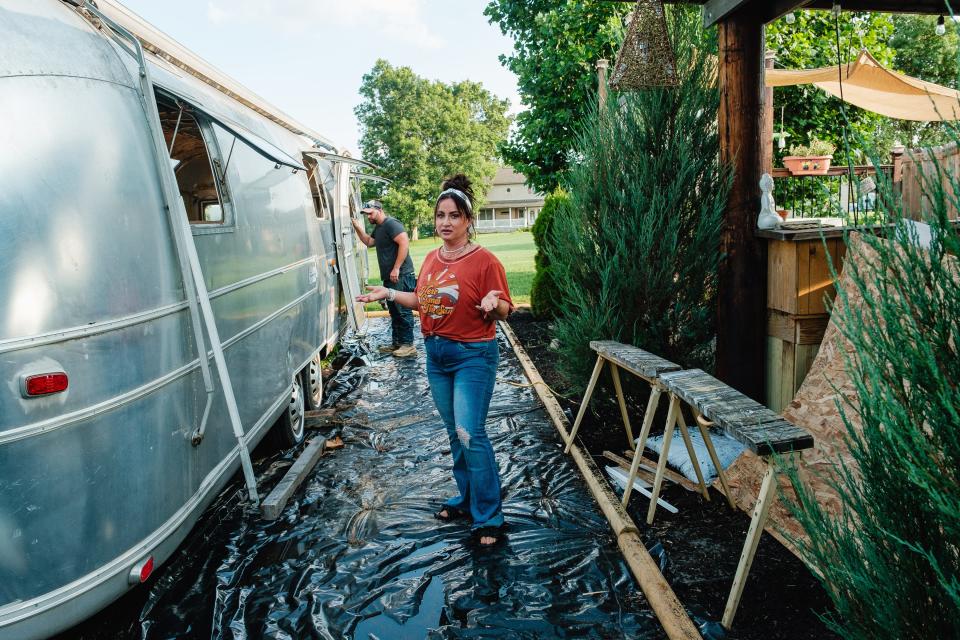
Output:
[791, 158, 960, 640]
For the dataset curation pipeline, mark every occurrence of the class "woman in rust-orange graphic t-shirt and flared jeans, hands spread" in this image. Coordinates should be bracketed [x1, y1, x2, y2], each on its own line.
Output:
[357, 174, 513, 546]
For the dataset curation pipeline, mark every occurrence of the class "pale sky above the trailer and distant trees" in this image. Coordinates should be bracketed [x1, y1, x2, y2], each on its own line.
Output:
[120, 0, 522, 155]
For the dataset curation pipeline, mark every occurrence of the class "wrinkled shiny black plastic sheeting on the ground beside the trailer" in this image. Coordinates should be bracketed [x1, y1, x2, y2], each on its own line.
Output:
[129, 319, 676, 640]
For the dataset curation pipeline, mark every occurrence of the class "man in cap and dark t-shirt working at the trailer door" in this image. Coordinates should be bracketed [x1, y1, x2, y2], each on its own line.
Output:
[351, 200, 417, 358]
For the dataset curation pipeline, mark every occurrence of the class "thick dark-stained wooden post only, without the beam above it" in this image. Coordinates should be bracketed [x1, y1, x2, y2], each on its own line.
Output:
[717, 10, 767, 400]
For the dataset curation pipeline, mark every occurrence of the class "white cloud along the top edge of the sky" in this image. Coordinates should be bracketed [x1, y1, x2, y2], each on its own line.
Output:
[207, 0, 444, 49]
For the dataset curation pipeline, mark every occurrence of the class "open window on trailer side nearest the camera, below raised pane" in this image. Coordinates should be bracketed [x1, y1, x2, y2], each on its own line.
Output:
[157, 99, 232, 225]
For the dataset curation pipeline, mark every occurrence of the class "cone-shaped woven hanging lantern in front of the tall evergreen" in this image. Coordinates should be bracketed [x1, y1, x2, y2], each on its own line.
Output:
[610, 0, 678, 91]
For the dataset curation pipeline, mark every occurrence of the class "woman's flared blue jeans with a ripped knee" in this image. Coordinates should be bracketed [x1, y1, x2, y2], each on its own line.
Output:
[423, 336, 503, 529]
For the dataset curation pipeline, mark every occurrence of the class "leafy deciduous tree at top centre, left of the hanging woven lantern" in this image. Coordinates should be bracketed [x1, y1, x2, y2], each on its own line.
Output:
[484, 0, 630, 193]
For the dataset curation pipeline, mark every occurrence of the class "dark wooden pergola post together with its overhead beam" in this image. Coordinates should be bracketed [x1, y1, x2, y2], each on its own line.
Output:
[648, 0, 949, 400]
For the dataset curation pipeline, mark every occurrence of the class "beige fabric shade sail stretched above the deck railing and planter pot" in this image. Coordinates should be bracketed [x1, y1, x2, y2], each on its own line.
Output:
[766, 50, 960, 122]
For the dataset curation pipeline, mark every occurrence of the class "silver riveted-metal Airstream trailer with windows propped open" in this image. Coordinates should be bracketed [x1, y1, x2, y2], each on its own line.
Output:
[0, 0, 366, 640]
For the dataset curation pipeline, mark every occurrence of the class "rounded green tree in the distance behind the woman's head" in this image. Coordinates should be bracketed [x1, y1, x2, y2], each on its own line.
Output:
[354, 60, 510, 234]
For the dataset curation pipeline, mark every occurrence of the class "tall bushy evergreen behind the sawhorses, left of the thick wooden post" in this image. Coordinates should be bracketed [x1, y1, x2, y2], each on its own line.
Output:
[546, 7, 730, 388]
